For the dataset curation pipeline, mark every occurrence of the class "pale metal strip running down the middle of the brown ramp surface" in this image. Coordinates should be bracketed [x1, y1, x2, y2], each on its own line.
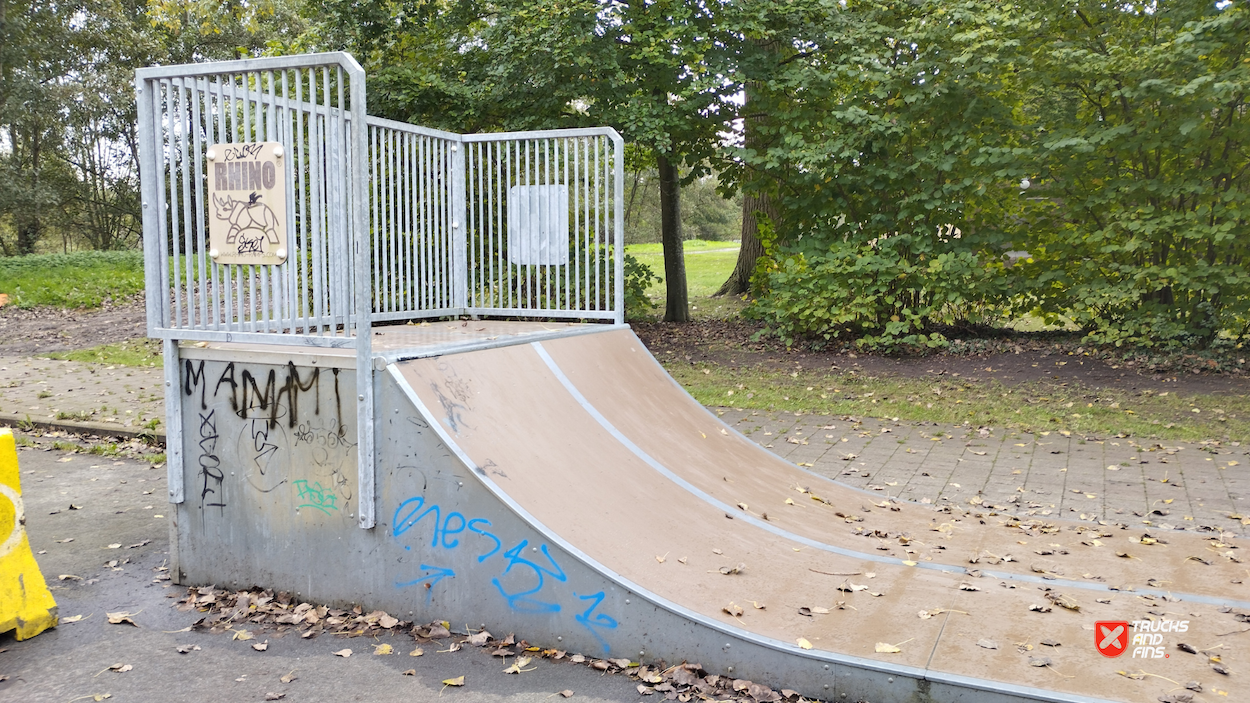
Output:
[531, 341, 1250, 608]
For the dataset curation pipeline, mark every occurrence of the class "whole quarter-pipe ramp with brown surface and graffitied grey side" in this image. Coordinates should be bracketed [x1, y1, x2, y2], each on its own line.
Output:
[174, 326, 1250, 703]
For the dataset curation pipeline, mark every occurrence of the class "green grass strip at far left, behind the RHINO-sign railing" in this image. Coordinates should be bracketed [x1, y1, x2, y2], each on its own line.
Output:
[0, 251, 144, 308]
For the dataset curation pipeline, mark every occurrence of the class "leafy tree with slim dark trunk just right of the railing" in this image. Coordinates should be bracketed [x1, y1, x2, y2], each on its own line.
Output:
[310, 0, 736, 321]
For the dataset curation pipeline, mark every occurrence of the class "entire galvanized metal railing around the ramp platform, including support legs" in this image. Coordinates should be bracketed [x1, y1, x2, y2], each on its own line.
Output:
[135, 53, 625, 528]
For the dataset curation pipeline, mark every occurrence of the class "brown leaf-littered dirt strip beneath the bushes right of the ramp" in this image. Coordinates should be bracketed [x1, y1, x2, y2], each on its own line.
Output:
[633, 320, 1250, 395]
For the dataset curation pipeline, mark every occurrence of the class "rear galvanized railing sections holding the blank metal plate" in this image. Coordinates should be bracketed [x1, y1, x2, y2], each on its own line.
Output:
[369, 118, 624, 323]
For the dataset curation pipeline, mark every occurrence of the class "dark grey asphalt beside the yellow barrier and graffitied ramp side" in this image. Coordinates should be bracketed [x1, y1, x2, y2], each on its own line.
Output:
[0, 449, 654, 703]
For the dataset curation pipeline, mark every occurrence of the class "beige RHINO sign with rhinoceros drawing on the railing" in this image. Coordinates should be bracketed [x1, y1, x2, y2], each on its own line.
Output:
[205, 141, 286, 264]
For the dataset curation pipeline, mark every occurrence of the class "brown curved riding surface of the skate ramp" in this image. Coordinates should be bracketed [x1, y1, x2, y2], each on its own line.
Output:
[399, 329, 1250, 702]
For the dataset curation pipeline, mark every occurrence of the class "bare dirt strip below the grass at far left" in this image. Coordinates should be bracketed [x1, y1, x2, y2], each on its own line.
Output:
[0, 295, 148, 354]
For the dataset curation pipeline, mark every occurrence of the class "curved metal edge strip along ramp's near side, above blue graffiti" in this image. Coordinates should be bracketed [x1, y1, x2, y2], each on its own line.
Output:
[386, 364, 1116, 703]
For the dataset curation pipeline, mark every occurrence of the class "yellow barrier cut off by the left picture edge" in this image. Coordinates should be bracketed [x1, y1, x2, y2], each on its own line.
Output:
[0, 429, 56, 639]
